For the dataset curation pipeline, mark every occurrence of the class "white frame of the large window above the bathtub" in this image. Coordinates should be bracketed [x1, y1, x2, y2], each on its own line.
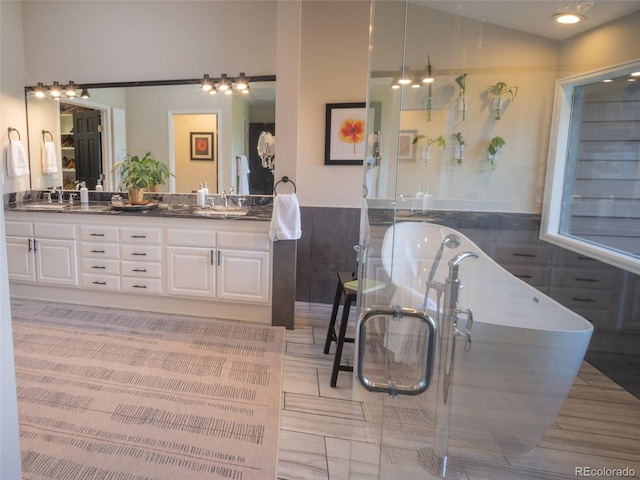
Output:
[540, 59, 640, 275]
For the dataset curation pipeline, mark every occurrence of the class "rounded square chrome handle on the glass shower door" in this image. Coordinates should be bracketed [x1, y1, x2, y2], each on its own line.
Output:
[356, 306, 437, 397]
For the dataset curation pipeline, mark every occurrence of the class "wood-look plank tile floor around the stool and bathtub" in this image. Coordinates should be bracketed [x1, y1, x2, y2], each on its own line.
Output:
[278, 303, 640, 480]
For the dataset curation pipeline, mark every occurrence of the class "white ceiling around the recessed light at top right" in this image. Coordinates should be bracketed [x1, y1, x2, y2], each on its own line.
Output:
[412, 0, 640, 40]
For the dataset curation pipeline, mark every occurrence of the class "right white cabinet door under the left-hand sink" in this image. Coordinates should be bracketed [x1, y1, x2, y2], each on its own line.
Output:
[35, 239, 78, 285]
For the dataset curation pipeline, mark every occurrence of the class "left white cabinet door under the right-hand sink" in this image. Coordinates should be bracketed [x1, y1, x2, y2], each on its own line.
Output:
[167, 247, 215, 298]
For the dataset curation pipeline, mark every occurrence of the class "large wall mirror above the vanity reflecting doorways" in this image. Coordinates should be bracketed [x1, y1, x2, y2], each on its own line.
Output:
[25, 76, 275, 194]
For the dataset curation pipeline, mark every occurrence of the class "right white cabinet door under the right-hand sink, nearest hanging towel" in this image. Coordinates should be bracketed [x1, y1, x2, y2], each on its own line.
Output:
[216, 249, 269, 303]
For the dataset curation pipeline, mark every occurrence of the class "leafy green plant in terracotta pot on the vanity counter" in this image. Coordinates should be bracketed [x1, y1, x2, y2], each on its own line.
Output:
[113, 151, 173, 205]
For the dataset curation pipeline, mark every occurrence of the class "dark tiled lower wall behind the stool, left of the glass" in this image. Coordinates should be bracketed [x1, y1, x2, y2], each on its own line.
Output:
[296, 207, 360, 303]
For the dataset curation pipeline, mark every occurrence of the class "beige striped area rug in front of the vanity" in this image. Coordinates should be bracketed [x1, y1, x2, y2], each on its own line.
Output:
[13, 303, 285, 480]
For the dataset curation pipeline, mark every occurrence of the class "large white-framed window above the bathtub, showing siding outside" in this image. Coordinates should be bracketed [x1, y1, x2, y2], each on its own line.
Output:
[541, 63, 640, 274]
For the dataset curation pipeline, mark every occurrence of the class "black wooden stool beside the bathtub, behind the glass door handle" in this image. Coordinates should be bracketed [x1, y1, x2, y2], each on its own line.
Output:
[324, 272, 358, 387]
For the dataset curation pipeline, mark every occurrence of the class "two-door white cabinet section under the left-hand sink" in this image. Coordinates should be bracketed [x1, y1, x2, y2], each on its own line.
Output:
[5, 220, 78, 286]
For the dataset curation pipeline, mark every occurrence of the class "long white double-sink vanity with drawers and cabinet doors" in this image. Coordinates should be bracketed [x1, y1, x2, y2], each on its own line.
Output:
[5, 204, 273, 324]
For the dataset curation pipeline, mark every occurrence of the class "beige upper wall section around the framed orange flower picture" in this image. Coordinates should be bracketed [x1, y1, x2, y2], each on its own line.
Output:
[296, 1, 369, 207]
